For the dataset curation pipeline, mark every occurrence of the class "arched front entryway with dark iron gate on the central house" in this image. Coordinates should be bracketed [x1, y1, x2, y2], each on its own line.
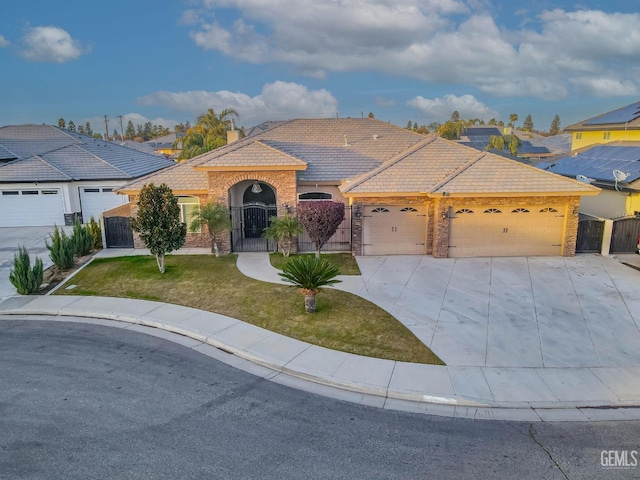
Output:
[229, 181, 278, 252]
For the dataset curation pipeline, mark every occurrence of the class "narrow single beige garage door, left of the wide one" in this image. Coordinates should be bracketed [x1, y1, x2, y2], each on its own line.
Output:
[362, 205, 427, 255]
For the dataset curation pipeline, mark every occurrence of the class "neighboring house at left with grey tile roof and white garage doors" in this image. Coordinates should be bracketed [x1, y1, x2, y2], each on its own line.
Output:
[0, 125, 174, 227]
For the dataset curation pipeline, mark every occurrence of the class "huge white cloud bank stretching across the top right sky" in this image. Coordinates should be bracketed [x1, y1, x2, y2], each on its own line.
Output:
[188, 0, 640, 99]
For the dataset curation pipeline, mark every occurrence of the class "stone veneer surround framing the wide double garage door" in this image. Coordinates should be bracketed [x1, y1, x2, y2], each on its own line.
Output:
[430, 197, 580, 258]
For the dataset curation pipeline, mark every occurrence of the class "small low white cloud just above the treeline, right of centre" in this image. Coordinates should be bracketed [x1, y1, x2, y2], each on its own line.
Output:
[407, 94, 499, 121]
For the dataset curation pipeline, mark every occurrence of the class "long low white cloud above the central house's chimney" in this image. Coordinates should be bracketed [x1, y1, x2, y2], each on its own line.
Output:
[138, 81, 338, 126]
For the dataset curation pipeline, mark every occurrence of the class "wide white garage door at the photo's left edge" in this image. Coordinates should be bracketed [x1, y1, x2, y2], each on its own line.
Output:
[0, 188, 64, 227]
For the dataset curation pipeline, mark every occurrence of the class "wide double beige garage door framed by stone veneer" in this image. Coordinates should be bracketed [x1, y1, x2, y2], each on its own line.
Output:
[449, 205, 566, 257]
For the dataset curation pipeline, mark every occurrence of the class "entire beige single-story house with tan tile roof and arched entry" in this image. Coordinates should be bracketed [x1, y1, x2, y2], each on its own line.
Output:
[120, 119, 599, 257]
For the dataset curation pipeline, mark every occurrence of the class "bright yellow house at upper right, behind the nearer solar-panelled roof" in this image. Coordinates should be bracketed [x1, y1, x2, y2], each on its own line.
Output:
[565, 102, 640, 150]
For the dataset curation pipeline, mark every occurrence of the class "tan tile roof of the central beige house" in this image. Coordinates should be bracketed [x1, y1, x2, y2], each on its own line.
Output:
[115, 119, 598, 196]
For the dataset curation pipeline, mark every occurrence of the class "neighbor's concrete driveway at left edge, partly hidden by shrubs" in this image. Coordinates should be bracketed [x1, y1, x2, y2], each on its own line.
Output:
[0, 226, 71, 299]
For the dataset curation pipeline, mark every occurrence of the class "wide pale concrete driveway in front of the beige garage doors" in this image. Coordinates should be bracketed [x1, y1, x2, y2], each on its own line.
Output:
[354, 255, 640, 367]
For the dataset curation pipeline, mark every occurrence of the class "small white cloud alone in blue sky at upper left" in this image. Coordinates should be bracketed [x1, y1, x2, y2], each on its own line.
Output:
[20, 25, 91, 63]
